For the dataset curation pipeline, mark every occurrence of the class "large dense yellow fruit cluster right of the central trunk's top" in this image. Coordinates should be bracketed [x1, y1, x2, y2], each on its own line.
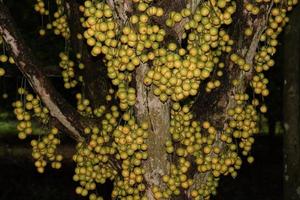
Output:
[144, 3, 235, 102]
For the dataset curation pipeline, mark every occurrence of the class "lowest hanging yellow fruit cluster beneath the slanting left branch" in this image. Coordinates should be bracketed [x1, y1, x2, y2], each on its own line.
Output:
[31, 128, 63, 173]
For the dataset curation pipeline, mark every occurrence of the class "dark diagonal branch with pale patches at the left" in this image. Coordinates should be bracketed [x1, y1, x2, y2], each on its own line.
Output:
[0, 3, 88, 141]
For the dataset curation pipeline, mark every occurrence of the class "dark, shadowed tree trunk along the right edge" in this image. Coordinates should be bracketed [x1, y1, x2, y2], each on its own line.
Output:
[283, 6, 300, 200]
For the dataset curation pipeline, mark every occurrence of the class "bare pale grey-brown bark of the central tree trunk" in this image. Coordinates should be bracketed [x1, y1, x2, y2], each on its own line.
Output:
[135, 64, 170, 200]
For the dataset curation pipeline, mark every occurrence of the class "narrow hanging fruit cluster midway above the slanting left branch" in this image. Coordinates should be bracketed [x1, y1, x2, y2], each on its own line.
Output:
[59, 52, 78, 89]
